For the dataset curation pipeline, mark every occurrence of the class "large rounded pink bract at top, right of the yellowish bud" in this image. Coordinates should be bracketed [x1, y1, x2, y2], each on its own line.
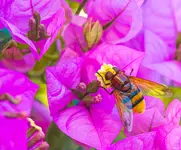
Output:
[87, 0, 142, 44]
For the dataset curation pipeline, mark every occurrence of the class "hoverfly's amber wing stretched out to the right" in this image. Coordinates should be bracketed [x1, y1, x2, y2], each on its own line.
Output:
[129, 76, 172, 98]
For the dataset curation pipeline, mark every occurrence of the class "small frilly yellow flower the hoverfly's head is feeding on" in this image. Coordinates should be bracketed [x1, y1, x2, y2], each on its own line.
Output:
[95, 63, 116, 88]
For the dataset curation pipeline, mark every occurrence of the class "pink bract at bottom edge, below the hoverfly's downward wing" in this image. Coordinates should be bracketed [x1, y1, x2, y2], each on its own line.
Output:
[106, 132, 156, 150]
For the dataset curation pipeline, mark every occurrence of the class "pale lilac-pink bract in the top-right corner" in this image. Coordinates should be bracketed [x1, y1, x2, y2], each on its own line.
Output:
[143, 0, 177, 47]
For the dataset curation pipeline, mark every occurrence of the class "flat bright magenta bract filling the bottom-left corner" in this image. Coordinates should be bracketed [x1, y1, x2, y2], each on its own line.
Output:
[0, 116, 28, 150]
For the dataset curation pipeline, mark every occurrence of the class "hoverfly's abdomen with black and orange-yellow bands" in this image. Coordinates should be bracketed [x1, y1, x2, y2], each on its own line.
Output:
[122, 85, 145, 113]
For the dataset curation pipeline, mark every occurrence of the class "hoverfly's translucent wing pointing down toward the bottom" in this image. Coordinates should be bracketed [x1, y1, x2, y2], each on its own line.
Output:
[114, 90, 133, 132]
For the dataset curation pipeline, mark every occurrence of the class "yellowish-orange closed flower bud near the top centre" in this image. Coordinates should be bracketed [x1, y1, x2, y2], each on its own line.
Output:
[84, 19, 103, 48]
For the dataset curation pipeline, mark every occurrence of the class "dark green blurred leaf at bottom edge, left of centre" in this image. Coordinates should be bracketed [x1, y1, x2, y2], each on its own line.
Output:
[46, 122, 80, 150]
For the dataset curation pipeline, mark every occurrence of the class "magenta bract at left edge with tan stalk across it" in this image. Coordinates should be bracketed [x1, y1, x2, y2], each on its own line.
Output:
[0, 69, 38, 115]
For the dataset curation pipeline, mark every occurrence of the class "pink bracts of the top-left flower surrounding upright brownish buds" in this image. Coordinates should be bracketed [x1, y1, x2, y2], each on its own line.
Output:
[0, 0, 65, 59]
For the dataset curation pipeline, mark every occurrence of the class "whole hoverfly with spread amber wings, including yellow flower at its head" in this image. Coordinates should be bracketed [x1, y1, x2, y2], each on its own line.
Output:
[96, 64, 172, 132]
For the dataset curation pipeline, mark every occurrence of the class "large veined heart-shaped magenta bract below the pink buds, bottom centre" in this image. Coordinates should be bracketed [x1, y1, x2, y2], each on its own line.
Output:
[54, 106, 120, 149]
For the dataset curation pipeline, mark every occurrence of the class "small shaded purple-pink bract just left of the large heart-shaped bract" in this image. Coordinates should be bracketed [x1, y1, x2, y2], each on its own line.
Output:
[31, 100, 52, 133]
